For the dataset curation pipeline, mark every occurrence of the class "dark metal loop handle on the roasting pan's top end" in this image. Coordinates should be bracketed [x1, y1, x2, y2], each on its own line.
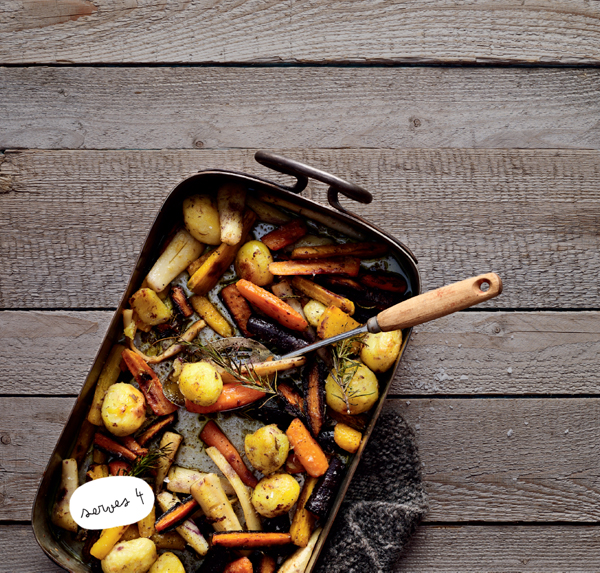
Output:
[254, 151, 373, 206]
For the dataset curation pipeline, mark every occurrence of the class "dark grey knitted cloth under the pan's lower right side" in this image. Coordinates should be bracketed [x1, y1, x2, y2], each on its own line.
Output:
[316, 409, 427, 573]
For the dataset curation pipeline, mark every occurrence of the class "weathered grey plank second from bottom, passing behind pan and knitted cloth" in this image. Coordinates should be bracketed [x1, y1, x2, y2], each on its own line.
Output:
[0, 397, 600, 523]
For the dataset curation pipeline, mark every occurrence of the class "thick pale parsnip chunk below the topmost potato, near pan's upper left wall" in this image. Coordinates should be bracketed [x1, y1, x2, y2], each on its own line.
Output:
[147, 230, 204, 290]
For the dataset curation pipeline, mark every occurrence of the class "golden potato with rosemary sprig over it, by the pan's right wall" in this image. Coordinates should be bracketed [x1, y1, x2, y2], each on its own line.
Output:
[325, 364, 379, 414]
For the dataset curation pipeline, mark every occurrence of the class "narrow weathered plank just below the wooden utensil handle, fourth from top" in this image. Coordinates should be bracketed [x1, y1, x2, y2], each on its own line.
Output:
[0, 311, 600, 396]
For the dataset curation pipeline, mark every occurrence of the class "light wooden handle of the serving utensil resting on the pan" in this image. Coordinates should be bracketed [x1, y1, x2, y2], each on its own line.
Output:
[368, 273, 502, 332]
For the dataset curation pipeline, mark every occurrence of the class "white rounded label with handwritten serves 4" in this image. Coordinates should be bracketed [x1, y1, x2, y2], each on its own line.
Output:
[69, 476, 154, 529]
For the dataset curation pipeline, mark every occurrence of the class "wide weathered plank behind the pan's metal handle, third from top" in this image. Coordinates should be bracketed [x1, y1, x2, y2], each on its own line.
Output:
[0, 149, 600, 309]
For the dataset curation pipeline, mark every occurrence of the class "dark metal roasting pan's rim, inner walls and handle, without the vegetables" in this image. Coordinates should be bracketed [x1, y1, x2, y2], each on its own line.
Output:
[32, 151, 421, 573]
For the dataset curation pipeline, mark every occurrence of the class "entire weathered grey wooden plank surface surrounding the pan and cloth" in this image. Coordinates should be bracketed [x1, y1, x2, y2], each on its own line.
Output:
[0, 0, 600, 573]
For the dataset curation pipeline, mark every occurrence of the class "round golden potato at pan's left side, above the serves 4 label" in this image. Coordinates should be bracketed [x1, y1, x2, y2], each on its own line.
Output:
[102, 382, 146, 436]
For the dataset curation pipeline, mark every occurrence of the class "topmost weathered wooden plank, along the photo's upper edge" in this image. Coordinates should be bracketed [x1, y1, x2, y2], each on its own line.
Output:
[0, 0, 600, 64]
